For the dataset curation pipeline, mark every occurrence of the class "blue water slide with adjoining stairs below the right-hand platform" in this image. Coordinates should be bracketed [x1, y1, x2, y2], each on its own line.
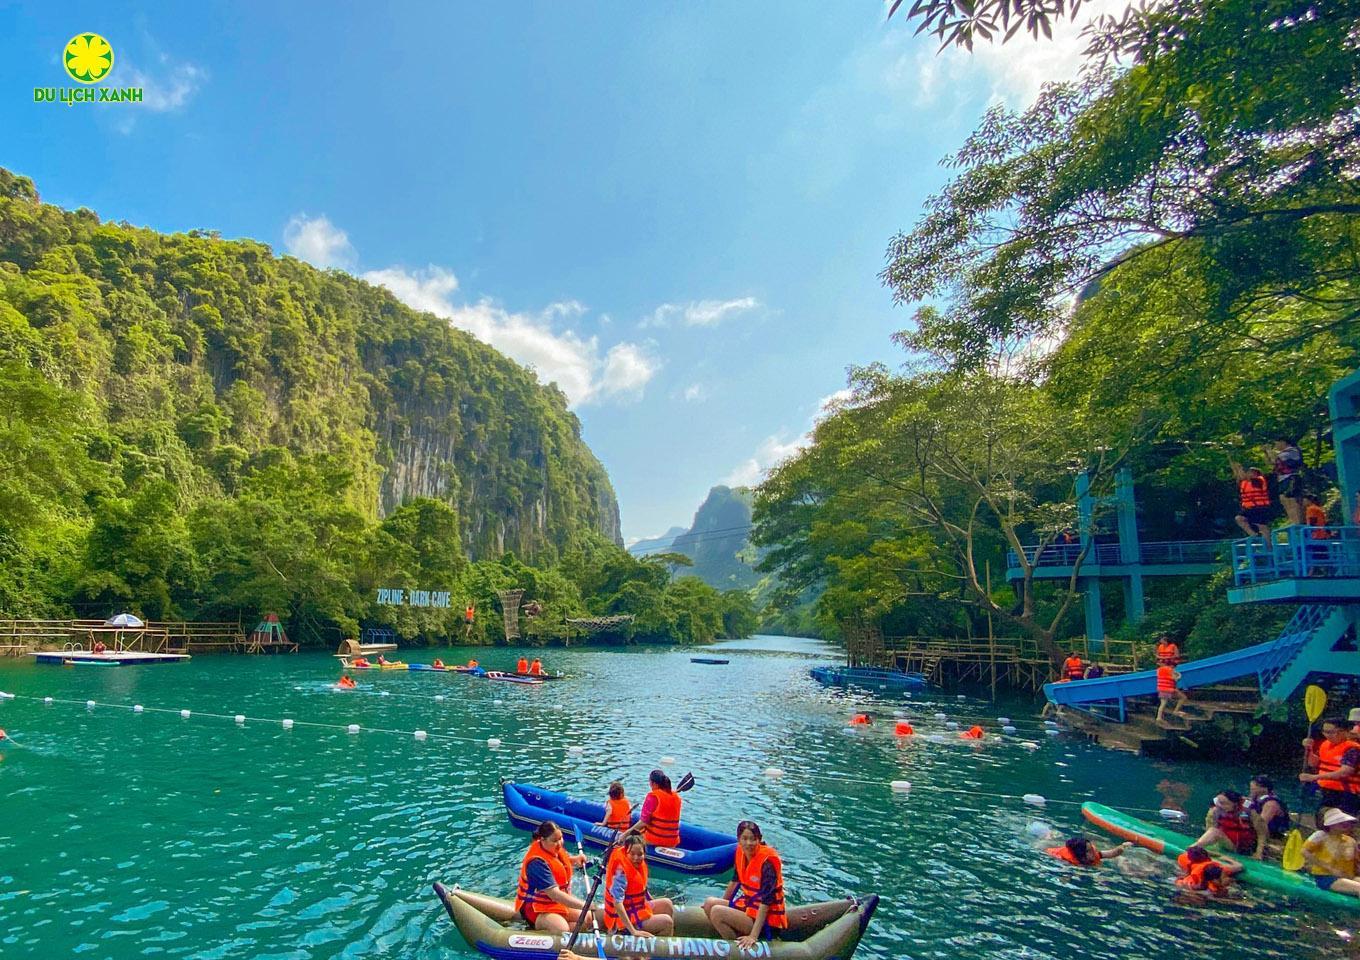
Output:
[1043, 604, 1360, 723]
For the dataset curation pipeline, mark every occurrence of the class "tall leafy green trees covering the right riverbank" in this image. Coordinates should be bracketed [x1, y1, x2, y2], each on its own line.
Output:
[753, 0, 1360, 655]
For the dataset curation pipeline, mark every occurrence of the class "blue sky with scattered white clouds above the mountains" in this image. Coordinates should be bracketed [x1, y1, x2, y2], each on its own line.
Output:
[0, 0, 1118, 538]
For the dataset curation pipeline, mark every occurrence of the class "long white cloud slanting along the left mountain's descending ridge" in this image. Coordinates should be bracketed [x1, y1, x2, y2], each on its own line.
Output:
[360, 267, 661, 407]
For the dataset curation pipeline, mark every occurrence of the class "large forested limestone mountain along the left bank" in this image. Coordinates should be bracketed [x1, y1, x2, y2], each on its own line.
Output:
[0, 169, 622, 616]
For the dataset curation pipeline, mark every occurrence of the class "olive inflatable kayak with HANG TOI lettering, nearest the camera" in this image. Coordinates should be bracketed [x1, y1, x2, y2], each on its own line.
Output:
[434, 884, 879, 960]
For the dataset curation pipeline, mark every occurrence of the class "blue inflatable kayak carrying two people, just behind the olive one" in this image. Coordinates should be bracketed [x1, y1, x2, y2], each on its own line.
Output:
[500, 781, 737, 874]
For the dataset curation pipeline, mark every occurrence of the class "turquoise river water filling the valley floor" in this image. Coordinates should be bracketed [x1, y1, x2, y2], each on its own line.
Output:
[0, 636, 1360, 960]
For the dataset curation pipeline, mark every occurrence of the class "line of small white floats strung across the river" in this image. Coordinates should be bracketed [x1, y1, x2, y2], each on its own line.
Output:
[0, 691, 1169, 820]
